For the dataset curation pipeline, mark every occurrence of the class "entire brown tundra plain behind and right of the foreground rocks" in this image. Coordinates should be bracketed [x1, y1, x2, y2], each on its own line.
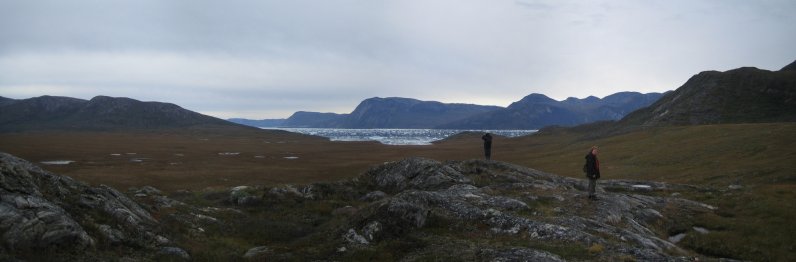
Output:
[0, 123, 796, 261]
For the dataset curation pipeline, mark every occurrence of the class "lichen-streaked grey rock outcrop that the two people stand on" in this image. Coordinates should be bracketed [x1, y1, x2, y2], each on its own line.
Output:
[340, 158, 715, 261]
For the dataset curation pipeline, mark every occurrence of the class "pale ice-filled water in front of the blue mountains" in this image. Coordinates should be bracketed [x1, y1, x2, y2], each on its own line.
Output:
[274, 128, 537, 145]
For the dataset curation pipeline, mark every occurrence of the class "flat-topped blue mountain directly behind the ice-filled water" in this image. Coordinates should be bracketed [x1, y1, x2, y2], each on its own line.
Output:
[331, 97, 501, 128]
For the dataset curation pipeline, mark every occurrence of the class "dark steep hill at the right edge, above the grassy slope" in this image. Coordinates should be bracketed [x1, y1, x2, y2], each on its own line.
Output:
[620, 62, 796, 126]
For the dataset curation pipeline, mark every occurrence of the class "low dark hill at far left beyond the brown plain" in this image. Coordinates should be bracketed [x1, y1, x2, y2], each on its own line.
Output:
[0, 96, 253, 132]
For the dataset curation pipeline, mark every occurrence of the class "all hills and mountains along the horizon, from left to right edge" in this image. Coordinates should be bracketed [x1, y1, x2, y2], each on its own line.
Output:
[0, 59, 796, 132]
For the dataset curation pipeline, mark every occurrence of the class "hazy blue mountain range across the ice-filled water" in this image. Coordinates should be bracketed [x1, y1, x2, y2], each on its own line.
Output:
[229, 92, 662, 129]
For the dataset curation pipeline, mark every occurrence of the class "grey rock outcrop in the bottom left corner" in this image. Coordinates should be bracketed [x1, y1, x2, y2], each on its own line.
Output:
[0, 153, 168, 258]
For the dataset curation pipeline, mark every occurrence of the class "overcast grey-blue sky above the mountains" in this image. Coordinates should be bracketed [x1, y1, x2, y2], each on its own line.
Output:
[0, 0, 796, 119]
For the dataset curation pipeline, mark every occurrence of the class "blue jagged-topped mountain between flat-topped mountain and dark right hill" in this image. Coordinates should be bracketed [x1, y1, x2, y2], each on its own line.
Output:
[438, 92, 663, 129]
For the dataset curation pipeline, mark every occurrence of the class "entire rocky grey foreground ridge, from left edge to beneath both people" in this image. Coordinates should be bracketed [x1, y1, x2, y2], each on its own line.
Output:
[0, 151, 715, 261]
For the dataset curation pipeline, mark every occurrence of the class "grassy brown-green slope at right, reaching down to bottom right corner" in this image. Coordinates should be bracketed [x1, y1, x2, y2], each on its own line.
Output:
[497, 123, 796, 261]
